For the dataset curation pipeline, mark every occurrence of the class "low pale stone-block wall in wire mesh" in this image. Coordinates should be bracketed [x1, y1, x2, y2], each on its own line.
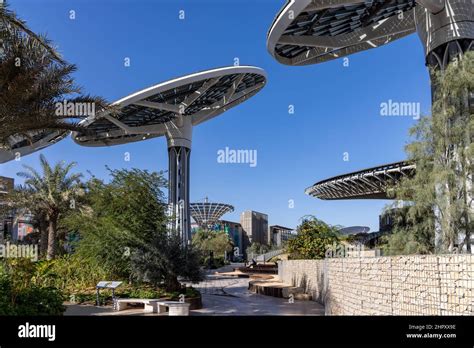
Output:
[278, 255, 474, 315]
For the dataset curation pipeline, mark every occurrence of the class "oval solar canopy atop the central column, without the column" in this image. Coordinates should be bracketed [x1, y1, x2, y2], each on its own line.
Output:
[73, 66, 266, 146]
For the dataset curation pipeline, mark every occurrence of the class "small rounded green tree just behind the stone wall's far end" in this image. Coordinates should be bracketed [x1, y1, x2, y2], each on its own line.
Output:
[287, 216, 339, 259]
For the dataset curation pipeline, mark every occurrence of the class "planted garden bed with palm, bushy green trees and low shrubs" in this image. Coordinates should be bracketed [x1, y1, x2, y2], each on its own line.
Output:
[0, 156, 205, 315]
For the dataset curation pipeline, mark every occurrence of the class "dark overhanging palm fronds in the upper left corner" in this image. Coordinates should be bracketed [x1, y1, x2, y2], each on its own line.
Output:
[0, 1, 108, 149]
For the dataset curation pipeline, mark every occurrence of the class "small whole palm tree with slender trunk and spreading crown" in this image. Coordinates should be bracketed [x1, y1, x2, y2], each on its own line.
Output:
[17, 155, 84, 260]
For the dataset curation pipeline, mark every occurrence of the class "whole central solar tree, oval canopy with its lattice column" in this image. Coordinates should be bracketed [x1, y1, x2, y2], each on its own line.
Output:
[73, 66, 266, 244]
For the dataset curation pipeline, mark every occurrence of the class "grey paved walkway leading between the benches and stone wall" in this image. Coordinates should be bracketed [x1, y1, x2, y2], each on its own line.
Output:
[183, 266, 324, 315]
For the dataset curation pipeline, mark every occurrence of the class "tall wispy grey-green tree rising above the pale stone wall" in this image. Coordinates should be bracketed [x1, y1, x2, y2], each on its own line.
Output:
[389, 52, 474, 253]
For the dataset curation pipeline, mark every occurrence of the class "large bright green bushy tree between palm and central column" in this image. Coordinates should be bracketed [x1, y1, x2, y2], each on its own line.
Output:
[69, 169, 166, 277]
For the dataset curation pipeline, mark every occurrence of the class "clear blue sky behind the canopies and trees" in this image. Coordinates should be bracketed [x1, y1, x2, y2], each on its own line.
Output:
[0, 0, 431, 231]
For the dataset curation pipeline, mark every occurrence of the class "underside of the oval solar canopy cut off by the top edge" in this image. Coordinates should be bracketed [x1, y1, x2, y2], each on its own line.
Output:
[267, 0, 416, 65]
